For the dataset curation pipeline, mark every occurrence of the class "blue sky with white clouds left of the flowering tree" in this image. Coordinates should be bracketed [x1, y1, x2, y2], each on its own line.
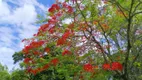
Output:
[0, 0, 63, 70]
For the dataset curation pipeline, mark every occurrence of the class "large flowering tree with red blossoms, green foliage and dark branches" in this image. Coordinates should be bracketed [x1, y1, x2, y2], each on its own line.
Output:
[18, 0, 142, 80]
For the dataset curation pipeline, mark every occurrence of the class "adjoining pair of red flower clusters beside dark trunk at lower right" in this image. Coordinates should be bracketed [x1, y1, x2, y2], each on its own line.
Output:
[102, 62, 123, 71]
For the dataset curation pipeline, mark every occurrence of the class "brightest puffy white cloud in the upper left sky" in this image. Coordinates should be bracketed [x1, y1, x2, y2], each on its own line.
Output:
[7, 5, 37, 24]
